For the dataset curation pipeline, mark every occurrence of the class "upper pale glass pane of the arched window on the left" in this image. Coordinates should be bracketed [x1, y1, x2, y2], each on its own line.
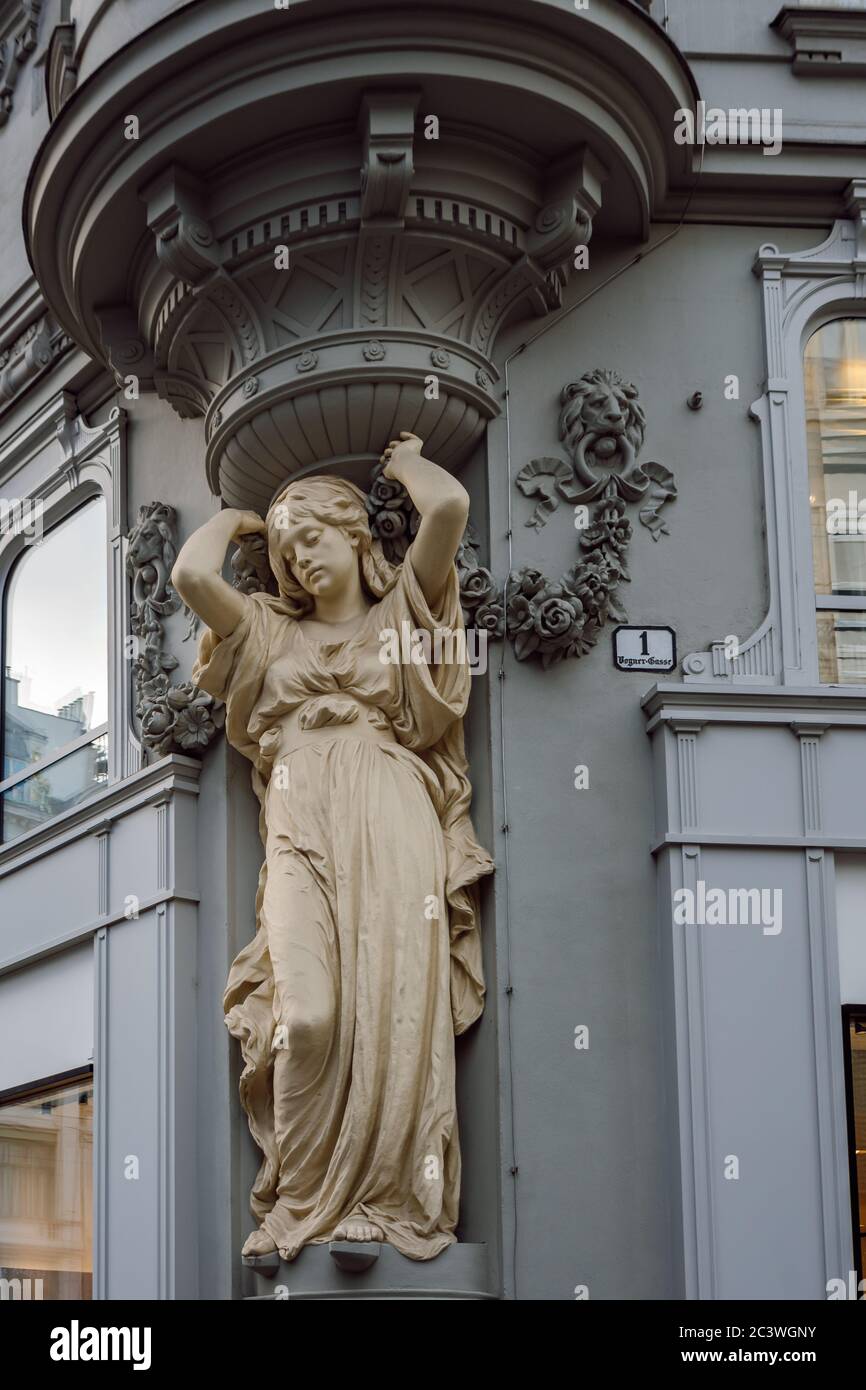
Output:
[3, 498, 108, 778]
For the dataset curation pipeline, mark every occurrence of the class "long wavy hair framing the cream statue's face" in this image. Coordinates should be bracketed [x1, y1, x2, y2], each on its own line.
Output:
[264, 474, 398, 619]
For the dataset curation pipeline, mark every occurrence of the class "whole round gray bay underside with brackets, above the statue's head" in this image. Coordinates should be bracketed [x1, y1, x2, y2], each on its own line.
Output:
[24, 0, 695, 507]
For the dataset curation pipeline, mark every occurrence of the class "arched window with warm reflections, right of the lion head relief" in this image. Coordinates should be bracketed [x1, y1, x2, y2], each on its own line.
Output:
[805, 318, 866, 685]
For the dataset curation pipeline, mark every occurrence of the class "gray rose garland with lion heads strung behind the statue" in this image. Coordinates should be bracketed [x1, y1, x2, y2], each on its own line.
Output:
[126, 368, 677, 758]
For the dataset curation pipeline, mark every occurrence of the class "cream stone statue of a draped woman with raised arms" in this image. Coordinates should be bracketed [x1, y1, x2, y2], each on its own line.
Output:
[172, 434, 492, 1259]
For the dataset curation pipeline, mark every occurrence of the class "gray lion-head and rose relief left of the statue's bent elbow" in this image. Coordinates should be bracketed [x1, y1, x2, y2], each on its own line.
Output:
[126, 502, 225, 758]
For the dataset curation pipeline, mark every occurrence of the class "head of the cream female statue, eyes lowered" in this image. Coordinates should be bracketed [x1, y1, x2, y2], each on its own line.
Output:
[265, 475, 396, 617]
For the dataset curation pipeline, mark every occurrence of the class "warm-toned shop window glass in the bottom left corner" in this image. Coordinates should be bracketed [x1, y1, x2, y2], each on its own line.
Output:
[0, 1079, 93, 1300]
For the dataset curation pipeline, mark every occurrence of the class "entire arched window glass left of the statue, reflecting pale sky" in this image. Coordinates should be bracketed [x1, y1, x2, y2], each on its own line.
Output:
[0, 496, 108, 842]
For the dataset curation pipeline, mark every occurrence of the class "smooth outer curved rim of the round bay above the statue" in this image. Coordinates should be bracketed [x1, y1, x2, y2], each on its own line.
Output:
[24, 0, 695, 357]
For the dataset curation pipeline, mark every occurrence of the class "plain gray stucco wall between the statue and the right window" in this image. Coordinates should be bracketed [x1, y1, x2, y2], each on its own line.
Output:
[488, 227, 820, 1300]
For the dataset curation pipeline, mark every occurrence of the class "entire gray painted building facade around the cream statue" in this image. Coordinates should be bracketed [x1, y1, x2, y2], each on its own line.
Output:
[0, 0, 866, 1300]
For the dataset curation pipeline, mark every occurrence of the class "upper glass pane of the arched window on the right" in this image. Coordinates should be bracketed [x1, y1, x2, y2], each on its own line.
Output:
[805, 318, 866, 594]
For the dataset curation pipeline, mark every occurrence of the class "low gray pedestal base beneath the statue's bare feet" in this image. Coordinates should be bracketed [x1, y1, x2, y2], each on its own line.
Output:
[243, 1245, 499, 1301]
